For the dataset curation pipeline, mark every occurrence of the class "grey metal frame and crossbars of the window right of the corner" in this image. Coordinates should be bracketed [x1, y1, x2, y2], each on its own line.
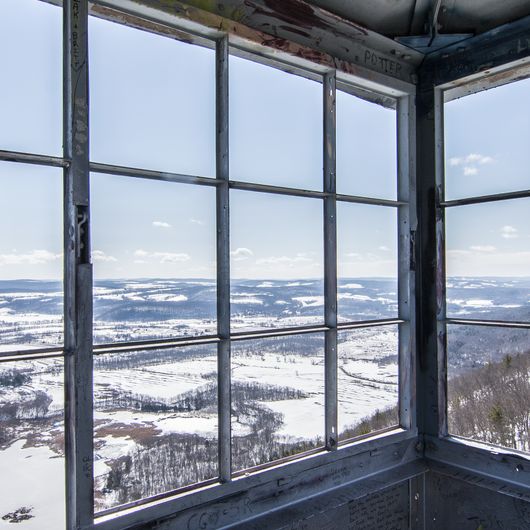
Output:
[424, 58, 530, 466]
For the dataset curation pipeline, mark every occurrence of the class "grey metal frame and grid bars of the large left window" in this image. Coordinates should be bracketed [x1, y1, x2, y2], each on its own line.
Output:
[0, 0, 417, 530]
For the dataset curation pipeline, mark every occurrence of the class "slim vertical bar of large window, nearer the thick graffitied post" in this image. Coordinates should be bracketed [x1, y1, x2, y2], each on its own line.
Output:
[215, 32, 232, 482]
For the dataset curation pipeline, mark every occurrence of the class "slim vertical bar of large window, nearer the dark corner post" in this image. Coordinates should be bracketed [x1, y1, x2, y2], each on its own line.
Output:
[323, 72, 338, 450]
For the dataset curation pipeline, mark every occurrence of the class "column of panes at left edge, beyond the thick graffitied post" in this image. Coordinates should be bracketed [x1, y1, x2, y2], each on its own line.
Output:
[0, 0, 65, 528]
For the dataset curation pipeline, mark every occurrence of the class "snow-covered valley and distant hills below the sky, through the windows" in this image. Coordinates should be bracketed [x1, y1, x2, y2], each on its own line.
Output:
[0, 278, 530, 528]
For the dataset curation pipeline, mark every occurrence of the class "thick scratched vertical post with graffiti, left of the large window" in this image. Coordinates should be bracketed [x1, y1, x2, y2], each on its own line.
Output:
[63, 0, 94, 530]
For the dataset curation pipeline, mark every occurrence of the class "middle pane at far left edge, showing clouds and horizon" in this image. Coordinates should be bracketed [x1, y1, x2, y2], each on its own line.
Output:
[0, 162, 63, 350]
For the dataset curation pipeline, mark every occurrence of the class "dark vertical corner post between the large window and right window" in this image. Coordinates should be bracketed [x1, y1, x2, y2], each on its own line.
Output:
[415, 80, 447, 437]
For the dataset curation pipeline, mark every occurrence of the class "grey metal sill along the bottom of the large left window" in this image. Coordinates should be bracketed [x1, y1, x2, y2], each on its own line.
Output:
[94, 428, 419, 530]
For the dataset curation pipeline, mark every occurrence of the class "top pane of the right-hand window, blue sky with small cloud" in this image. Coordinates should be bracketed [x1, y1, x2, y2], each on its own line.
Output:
[444, 79, 530, 199]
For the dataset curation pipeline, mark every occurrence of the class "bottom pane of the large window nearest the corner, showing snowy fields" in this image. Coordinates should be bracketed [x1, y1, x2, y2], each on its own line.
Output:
[338, 326, 399, 440]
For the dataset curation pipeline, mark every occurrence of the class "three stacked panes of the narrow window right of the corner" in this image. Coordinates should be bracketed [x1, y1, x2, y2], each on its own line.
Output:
[442, 80, 530, 452]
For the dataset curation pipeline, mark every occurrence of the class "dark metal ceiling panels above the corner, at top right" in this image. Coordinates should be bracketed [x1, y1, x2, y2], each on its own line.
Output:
[308, 0, 530, 38]
